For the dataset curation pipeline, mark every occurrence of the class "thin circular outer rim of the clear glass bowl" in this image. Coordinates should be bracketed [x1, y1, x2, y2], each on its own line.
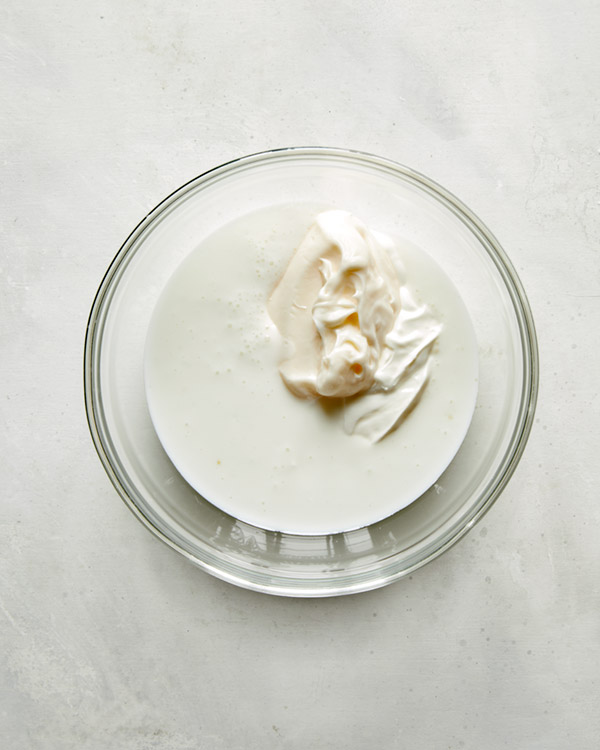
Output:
[83, 146, 539, 597]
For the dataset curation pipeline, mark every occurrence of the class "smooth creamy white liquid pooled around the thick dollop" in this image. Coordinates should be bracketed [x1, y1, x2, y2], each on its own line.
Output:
[145, 205, 477, 534]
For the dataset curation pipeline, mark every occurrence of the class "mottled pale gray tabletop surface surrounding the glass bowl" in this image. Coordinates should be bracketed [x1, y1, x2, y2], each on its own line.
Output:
[0, 0, 600, 750]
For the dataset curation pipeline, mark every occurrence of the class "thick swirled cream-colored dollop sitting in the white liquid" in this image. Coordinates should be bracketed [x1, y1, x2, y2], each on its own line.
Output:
[268, 210, 442, 443]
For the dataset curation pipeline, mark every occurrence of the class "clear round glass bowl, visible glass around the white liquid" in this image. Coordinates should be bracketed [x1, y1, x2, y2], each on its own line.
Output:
[84, 148, 538, 597]
